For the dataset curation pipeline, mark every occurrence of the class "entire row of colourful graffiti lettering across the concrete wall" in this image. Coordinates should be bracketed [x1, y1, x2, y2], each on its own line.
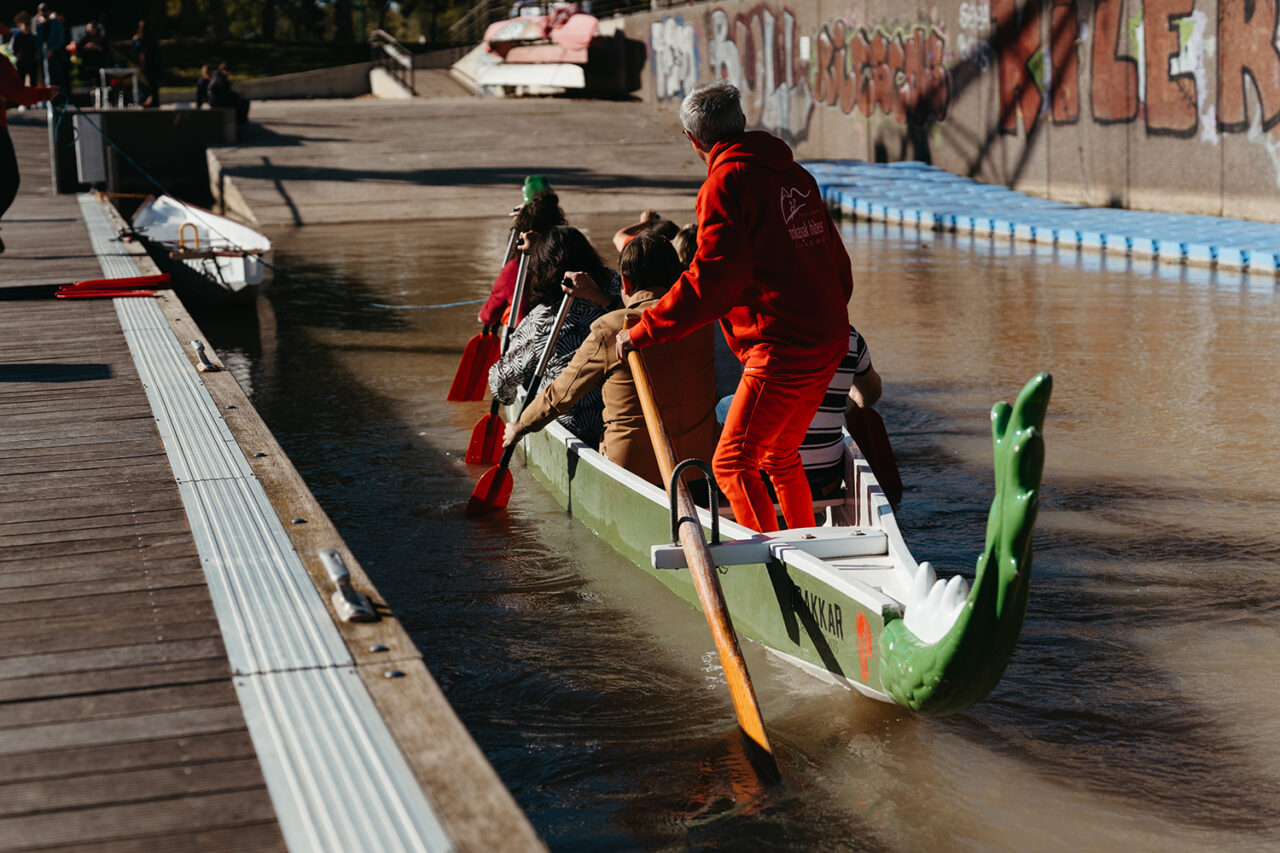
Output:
[650, 0, 1280, 169]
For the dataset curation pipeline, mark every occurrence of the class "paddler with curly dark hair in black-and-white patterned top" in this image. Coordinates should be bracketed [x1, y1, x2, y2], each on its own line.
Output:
[489, 225, 622, 447]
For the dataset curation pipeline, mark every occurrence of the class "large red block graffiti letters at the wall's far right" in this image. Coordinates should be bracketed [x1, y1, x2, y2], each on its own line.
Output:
[991, 0, 1280, 142]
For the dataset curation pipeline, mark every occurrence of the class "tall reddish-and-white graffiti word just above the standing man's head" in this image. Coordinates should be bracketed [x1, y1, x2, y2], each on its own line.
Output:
[707, 5, 813, 141]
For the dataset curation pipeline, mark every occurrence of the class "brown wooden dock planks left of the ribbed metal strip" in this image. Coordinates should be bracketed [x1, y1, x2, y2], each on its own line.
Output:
[0, 114, 284, 850]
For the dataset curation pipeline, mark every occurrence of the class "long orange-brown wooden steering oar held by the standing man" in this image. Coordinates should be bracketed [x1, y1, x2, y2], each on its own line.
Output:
[627, 338, 781, 779]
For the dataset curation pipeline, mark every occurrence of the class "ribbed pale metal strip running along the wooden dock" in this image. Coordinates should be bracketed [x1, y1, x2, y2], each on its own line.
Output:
[79, 190, 538, 853]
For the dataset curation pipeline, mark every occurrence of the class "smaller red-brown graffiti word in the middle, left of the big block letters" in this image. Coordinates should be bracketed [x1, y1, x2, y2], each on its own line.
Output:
[813, 20, 951, 122]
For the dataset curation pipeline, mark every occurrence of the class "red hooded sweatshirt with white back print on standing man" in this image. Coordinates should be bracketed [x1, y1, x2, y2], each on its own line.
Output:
[631, 131, 854, 366]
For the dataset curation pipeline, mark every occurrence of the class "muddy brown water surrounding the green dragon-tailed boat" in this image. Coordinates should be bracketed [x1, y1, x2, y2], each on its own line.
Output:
[189, 216, 1280, 850]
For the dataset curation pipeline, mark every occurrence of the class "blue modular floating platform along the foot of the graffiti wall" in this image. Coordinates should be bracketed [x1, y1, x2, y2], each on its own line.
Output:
[801, 160, 1280, 275]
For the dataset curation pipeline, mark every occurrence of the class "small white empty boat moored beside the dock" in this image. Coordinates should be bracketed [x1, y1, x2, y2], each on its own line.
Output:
[133, 196, 271, 305]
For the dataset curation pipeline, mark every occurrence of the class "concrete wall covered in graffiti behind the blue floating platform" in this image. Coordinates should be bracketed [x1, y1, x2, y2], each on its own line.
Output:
[622, 0, 1280, 222]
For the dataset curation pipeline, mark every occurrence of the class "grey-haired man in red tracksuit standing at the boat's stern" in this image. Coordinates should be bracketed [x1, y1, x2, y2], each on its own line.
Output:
[617, 82, 854, 533]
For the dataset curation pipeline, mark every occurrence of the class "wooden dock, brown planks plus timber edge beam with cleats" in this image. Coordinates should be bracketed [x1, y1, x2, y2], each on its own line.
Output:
[0, 113, 541, 850]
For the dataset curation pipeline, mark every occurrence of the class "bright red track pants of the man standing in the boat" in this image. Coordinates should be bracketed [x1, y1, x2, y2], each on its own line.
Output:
[712, 341, 849, 533]
